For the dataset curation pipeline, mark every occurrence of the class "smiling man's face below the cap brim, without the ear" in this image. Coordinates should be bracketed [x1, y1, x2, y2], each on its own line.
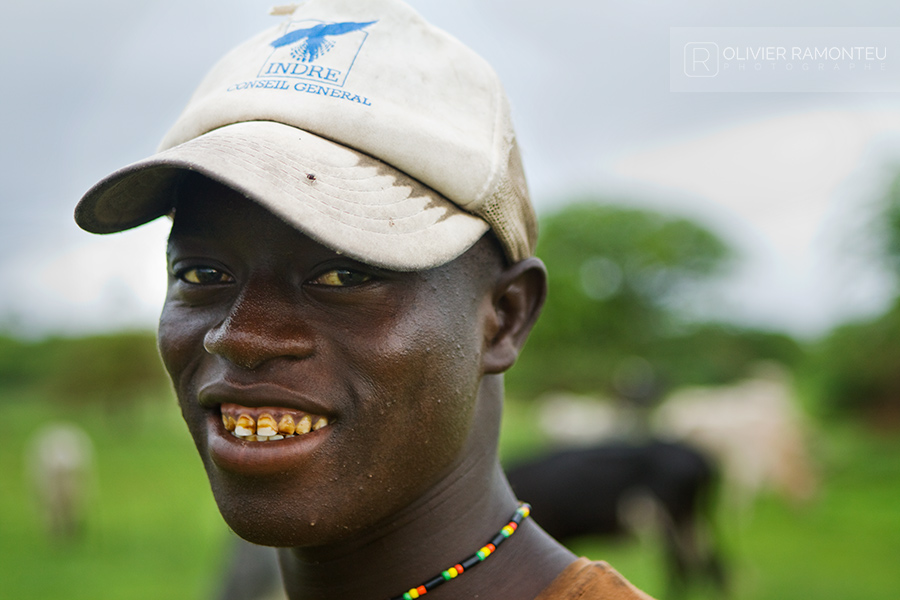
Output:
[159, 180, 500, 546]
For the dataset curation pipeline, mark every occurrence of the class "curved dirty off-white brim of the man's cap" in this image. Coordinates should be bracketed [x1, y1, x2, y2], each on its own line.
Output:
[75, 121, 489, 271]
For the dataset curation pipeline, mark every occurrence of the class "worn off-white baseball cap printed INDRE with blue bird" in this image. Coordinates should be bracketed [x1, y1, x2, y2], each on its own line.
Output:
[75, 0, 537, 271]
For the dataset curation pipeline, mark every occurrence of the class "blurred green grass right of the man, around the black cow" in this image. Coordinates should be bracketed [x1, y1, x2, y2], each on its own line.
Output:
[502, 398, 900, 600]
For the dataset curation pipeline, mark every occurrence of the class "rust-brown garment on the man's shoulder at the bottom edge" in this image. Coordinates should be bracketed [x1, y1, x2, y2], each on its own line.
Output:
[534, 558, 653, 600]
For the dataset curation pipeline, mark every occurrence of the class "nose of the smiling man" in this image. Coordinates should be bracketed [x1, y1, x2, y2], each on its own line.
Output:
[203, 283, 315, 370]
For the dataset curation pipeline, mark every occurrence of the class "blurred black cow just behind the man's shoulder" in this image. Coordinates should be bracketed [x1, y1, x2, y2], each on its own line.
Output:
[507, 441, 724, 597]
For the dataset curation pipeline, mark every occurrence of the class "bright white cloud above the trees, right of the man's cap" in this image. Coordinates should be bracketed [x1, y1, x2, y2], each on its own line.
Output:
[615, 110, 900, 333]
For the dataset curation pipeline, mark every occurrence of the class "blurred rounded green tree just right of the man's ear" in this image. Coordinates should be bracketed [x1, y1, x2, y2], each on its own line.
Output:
[508, 202, 732, 397]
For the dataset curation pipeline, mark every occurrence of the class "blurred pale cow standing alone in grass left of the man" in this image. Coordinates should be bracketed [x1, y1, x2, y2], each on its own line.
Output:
[26, 423, 94, 541]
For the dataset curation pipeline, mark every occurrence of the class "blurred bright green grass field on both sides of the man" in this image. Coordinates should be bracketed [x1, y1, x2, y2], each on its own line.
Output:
[0, 395, 900, 600]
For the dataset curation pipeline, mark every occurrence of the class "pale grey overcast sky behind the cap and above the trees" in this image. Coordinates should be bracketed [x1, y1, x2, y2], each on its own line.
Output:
[0, 0, 900, 335]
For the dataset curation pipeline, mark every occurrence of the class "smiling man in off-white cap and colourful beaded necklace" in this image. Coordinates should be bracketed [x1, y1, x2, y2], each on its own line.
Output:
[76, 0, 646, 600]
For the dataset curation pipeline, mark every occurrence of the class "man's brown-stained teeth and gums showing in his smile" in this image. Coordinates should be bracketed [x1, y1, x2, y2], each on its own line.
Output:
[221, 403, 329, 442]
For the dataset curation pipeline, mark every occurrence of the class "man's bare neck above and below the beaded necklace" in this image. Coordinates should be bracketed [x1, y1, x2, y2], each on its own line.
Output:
[279, 378, 574, 600]
